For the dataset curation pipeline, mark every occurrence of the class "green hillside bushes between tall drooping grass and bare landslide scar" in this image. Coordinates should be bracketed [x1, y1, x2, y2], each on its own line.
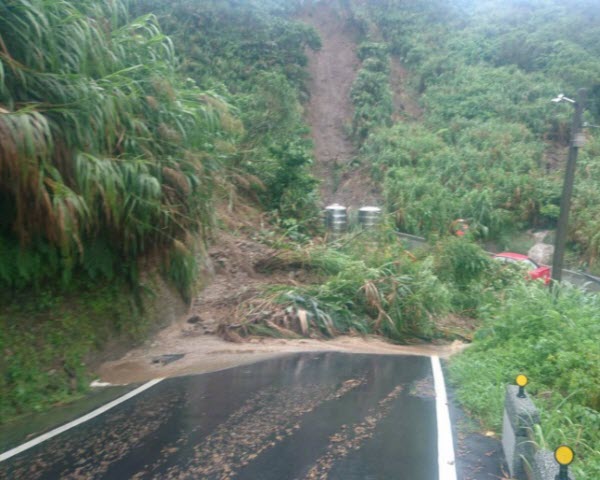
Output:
[136, 0, 320, 227]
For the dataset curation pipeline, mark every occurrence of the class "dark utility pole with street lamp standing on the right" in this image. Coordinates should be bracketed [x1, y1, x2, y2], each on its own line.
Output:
[552, 88, 587, 282]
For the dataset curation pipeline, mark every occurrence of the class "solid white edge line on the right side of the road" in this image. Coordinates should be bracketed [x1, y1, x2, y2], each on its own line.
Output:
[431, 356, 456, 480]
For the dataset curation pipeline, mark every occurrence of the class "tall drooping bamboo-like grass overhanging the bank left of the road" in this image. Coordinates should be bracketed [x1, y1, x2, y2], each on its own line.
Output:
[0, 0, 227, 284]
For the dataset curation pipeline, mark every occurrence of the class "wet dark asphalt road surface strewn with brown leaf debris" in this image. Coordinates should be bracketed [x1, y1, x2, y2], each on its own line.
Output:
[0, 353, 456, 480]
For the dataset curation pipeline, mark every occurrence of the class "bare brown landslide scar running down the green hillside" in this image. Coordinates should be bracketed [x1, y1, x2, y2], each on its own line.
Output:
[301, 1, 381, 207]
